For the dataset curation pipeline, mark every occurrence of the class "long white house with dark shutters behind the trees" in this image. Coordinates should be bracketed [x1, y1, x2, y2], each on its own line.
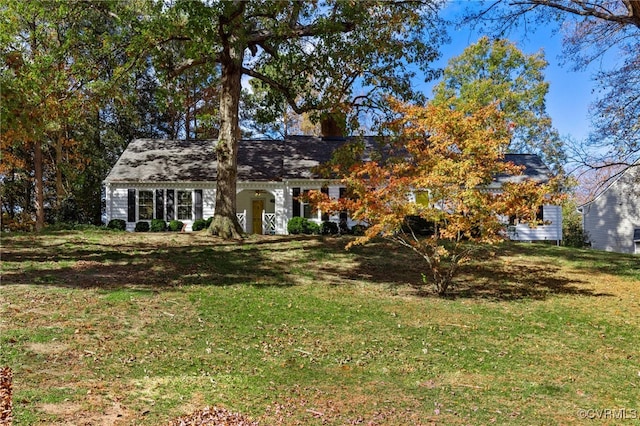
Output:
[104, 136, 562, 241]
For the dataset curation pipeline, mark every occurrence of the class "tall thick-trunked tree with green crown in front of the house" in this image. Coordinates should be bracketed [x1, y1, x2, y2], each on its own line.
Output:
[152, 0, 444, 238]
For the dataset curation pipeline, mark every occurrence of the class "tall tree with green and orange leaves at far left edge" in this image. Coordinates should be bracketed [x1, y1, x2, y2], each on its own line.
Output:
[0, 0, 146, 230]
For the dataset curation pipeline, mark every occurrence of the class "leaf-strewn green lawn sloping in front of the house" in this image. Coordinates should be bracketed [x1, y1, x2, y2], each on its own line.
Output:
[0, 231, 640, 425]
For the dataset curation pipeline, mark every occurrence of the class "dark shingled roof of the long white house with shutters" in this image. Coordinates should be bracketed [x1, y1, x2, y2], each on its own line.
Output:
[105, 136, 551, 183]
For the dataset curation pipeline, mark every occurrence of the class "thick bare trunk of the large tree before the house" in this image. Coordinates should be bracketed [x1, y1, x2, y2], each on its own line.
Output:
[209, 43, 243, 239]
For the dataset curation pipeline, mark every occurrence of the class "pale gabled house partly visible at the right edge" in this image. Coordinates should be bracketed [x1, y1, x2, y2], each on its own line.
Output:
[578, 161, 640, 254]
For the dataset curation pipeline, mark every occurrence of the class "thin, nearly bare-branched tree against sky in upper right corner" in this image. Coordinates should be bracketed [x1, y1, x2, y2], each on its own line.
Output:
[468, 0, 640, 176]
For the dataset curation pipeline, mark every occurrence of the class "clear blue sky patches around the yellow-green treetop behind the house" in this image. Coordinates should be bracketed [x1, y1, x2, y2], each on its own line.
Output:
[419, 2, 596, 141]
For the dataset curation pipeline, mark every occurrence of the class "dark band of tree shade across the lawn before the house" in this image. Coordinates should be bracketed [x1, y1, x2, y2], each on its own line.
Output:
[2, 232, 620, 300]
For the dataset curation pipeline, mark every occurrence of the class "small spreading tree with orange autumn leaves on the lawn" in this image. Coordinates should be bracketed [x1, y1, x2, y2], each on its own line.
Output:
[311, 98, 553, 294]
